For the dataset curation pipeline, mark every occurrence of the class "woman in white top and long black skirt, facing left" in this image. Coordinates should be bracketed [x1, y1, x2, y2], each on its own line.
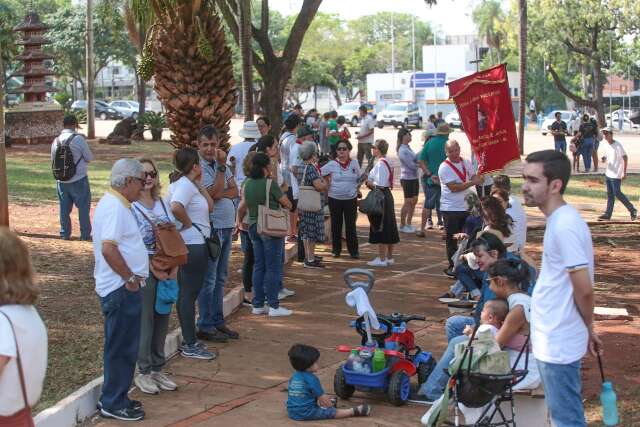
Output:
[366, 139, 400, 267]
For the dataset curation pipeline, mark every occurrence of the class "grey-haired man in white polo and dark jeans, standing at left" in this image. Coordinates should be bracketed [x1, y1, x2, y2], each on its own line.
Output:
[93, 159, 149, 421]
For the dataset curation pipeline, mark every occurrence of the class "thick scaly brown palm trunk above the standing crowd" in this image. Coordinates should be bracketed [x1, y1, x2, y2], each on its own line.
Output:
[134, 0, 236, 147]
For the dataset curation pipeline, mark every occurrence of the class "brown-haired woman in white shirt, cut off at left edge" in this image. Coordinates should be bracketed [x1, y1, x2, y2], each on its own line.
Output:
[0, 227, 47, 426]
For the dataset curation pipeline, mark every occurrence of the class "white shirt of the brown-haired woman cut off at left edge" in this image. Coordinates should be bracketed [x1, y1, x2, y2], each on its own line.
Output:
[0, 304, 47, 416]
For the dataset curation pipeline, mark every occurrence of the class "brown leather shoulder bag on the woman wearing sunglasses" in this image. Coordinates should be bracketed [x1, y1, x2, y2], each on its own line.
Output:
[135, 199, 189, 271]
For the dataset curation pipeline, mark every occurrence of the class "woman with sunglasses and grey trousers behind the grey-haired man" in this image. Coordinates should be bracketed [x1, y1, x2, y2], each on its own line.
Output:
[131, 158, 178, 394]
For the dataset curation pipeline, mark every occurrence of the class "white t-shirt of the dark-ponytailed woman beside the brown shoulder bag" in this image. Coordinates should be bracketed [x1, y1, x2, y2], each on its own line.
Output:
[167, 176, 211, 245]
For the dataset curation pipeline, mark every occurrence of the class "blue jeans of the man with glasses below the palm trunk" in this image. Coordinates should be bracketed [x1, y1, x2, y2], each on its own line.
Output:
[197, 228, 233, 332]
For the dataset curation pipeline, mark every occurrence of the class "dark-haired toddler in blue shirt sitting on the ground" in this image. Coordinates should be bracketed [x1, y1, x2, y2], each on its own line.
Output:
[287, 344, 371, 421]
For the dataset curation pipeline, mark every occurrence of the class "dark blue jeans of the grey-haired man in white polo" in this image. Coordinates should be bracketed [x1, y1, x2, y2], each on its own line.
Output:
[100, 285, 142, 410]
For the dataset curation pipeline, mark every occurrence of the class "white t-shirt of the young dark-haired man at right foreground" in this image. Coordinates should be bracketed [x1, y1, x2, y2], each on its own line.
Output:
[531, 205, 593, 364]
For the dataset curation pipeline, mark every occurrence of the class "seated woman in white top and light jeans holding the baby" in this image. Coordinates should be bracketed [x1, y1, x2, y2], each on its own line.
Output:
[417, 258, 540, 401]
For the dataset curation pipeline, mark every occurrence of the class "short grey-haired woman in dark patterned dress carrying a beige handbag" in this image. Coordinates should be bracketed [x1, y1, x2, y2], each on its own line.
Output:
[296, 141, 328, 268]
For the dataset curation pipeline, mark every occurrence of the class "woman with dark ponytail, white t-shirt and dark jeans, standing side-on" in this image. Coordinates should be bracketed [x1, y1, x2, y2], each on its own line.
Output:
[168, 147, 216, 360]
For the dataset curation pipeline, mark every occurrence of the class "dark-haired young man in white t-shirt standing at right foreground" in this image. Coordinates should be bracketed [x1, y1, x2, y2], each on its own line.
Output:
[522, 150, 602, 427]
